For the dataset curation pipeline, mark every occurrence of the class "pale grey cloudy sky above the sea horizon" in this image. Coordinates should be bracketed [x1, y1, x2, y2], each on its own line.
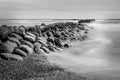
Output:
[0, 0, 120, 19]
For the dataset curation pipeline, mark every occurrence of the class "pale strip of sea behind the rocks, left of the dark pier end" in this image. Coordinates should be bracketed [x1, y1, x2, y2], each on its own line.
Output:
[0, 19, 78, 26]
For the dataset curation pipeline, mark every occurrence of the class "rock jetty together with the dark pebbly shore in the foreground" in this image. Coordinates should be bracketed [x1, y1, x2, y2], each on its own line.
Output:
[0, 22, 91, 80]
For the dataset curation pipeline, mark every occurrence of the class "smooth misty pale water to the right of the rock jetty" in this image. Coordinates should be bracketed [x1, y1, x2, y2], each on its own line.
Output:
[48, 22, 120, 80]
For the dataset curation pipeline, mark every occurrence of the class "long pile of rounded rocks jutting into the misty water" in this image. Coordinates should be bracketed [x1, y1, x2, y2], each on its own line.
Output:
[0, 22, 88, 60]
